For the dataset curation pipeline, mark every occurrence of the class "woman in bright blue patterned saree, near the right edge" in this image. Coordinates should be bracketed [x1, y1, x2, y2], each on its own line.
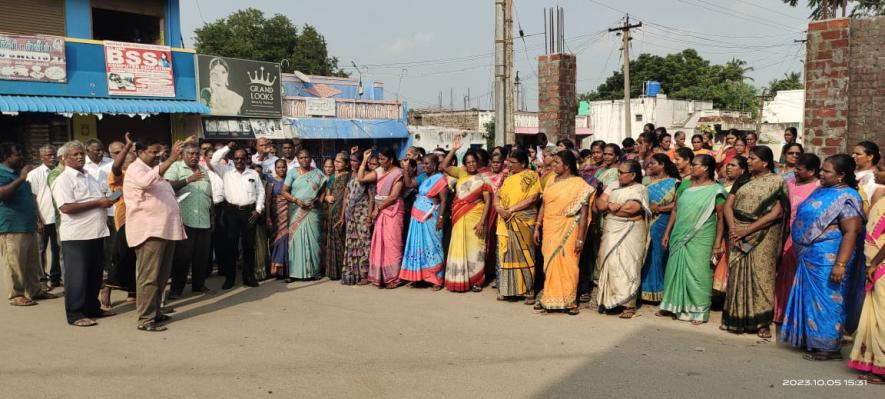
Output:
[780, 154, 864, 360]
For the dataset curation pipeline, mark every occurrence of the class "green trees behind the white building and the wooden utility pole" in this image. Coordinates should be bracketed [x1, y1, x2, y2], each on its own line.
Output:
[578, 49, 758, 112]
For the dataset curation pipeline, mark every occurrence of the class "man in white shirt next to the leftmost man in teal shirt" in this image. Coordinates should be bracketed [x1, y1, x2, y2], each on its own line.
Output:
[28, 145, 61, 288]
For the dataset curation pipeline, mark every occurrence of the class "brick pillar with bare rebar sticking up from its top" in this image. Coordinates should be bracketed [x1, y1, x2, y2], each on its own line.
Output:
[538, 53, 578, 143]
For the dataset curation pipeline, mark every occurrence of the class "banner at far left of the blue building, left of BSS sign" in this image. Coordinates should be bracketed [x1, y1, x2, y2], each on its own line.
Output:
[0, 34, 68, 83]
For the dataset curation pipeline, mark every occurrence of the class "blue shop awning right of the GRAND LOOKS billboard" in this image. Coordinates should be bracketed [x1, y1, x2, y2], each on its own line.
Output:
[285, 118, 409, 140]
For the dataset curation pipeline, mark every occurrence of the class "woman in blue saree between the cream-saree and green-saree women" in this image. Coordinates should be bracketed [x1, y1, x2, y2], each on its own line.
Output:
[641, 154, 679, 302]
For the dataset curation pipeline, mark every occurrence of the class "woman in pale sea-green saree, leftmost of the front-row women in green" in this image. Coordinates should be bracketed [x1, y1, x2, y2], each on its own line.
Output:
[283, 149, 326, 283]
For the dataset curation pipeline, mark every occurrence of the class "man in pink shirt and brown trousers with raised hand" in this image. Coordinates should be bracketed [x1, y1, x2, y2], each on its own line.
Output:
[123, 140, 186, 331]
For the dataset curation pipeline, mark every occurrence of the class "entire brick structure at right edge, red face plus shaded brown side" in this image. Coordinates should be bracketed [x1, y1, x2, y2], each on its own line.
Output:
[804, 17, 885, 155]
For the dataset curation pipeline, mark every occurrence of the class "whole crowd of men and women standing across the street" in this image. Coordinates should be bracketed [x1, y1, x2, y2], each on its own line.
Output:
[0, 125, 885, 383]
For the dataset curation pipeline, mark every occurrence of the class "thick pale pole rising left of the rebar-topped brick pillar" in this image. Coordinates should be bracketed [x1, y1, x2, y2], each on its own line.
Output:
[495, 0, 514, 145]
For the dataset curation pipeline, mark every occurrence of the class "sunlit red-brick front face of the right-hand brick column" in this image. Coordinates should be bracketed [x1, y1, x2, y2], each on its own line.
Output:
[804, 18, 850, 155]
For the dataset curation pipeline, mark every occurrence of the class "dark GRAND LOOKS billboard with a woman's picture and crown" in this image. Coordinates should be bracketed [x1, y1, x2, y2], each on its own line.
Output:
[197, 54, 283, 119]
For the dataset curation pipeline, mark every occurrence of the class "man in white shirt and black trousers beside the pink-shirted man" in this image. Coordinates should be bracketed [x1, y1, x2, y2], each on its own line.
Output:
[52, 141, 119, 327]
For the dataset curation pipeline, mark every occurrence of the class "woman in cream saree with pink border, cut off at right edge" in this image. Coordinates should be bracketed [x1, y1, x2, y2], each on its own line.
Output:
[848, 162, 885, 384]
